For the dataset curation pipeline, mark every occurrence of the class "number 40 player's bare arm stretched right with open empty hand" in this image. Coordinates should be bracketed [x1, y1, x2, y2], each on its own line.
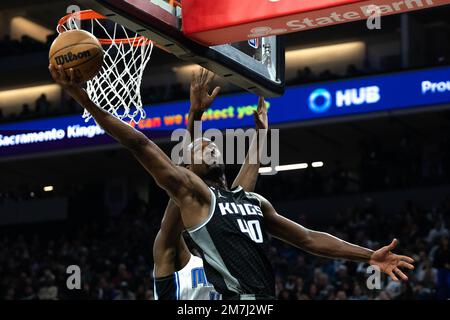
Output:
[260, 197, 414, 281]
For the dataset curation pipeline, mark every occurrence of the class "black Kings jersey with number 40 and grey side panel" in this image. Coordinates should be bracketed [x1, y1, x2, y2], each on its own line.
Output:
[187, 187, 275, 299]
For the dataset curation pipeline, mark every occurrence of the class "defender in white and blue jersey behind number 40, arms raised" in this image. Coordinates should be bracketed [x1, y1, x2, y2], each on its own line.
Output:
[153, 69, 268, 300]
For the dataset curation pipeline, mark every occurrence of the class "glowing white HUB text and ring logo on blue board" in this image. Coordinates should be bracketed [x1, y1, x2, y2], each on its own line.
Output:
[308, 86, 381, 113]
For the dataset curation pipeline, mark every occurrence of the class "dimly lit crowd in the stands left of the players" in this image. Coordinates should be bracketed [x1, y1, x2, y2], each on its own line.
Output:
[0, 198, 161, 300]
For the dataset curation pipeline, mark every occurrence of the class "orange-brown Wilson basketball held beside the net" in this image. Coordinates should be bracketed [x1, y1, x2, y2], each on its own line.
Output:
[49, 30, 103, 82]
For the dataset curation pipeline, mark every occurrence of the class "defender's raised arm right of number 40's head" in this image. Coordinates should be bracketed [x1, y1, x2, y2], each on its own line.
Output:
[232, 97, 269, 192]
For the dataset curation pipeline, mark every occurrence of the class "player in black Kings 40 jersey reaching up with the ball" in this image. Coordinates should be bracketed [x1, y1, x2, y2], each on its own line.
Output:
[50, 67, 414, 299]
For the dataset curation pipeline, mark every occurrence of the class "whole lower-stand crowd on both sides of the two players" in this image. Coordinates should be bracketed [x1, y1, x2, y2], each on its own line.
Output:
[0, 185, 450, 300]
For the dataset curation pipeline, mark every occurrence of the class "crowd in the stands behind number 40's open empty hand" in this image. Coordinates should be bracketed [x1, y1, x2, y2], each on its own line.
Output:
[271, 199, 450, 300]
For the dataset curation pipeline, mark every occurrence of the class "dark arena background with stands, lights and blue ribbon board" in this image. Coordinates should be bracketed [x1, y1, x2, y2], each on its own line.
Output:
[0, 0, 450, 308]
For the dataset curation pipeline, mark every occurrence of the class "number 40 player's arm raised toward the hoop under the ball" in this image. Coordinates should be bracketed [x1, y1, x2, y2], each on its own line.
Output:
[49, 66, 211, 214]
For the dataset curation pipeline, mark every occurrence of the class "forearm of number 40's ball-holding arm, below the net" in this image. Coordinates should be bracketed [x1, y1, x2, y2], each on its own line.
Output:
[73, 90, 148, 150]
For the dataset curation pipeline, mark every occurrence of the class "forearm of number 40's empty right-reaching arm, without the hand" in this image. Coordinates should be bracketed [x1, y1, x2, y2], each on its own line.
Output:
[302, 231, 373, 262]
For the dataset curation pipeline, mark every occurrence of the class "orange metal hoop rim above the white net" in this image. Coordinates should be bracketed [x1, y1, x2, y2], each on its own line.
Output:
[57, 9, 153, 46]
